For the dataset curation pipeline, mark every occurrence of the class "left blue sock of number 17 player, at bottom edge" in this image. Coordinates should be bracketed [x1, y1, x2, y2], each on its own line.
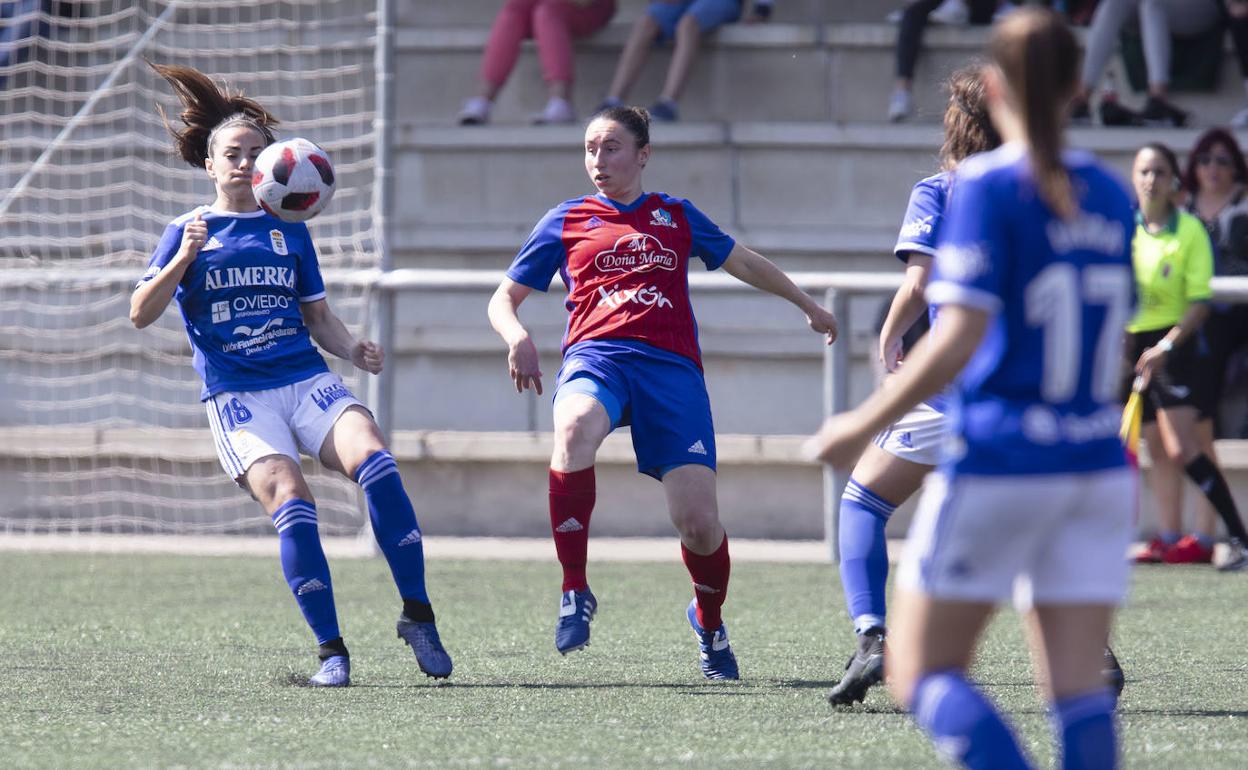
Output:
[911, 671, 1031, 770]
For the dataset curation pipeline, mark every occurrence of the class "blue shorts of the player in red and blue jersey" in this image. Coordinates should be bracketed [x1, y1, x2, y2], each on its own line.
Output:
[554, 339, 715, 480]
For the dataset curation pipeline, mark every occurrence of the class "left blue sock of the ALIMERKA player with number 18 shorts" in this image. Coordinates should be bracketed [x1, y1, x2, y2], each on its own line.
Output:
[273, 498, 342, 644]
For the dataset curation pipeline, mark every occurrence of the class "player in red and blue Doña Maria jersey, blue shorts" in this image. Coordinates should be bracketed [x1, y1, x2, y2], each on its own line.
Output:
[489, 107, 836, 679]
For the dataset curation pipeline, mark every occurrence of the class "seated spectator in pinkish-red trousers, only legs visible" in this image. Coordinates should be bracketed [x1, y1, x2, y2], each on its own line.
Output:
[459, 0, 615, 126]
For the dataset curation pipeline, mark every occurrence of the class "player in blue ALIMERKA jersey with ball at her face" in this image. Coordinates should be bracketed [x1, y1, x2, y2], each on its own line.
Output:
[130, 65, 452, 686]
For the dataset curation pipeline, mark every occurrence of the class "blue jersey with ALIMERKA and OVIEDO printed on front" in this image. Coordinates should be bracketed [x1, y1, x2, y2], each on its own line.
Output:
[140, 206, 329, 399]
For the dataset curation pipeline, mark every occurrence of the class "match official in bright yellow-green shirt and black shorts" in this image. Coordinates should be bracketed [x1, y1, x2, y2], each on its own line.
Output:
[1126, 142, 1248, 570]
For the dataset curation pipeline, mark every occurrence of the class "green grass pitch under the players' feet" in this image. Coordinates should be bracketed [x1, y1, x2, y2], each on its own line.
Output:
[0, 553, 1248, 770]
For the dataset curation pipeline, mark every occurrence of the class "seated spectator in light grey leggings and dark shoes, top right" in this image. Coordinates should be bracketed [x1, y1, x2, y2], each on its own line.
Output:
[1071, 0, 1221, 126]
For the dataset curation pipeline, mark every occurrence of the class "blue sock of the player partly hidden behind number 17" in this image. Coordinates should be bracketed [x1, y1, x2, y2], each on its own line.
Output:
[839, 478, 897, 634]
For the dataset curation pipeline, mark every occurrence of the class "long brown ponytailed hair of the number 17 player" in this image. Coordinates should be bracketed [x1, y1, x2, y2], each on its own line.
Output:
[988, 6, 1080, 218]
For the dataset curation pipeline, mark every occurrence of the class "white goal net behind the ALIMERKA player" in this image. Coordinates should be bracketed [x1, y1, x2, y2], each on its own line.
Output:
[0, 0, 378, 534]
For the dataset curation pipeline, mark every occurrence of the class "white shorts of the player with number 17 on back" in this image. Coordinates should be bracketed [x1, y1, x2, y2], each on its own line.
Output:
[897, 468, 1137, 610]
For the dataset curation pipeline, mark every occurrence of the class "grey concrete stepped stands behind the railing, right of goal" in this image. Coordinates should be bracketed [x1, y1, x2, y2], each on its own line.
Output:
[12, 0, 1248, 537]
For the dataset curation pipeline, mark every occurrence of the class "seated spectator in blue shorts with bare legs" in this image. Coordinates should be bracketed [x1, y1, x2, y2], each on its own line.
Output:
[600, 0, 774, 122]
